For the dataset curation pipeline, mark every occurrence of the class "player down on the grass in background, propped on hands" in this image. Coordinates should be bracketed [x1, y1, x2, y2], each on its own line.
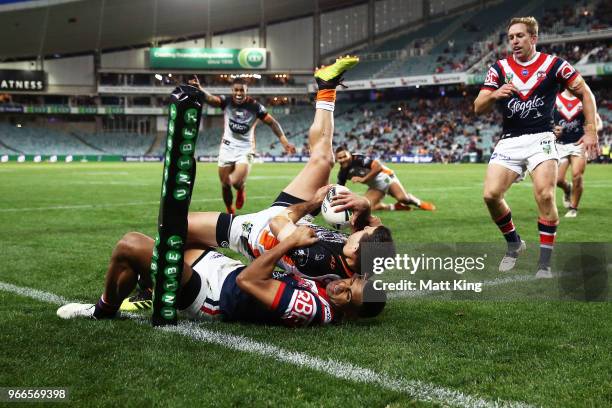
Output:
[336, 146, 436, 211]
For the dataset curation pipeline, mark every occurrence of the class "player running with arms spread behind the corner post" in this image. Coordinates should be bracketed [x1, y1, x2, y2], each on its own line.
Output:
[189, 77, 295, 214]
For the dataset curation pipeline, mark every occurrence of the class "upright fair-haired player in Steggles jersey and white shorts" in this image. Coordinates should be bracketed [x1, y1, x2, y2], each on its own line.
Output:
[474, 17, 598, 278]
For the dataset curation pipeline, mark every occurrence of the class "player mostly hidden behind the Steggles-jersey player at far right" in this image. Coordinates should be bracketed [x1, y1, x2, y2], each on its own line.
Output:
[554, 90, 603, 218]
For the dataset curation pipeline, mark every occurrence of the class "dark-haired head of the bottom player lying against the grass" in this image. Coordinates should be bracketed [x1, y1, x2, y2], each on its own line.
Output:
[325, 274, 387, 318]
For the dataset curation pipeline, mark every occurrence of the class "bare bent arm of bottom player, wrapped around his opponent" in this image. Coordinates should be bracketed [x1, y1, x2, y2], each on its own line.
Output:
[236, 226, 317, 307]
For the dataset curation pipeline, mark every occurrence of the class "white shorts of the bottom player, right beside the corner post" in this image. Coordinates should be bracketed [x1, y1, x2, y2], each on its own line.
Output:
[181, 251, 244, 320]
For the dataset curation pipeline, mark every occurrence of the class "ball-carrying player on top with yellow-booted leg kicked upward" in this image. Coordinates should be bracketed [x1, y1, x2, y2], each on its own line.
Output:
[122, 57, 393, 310]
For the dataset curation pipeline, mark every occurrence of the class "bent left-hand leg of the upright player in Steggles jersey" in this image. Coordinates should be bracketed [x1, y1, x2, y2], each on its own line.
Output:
[483, 163, 524, 272]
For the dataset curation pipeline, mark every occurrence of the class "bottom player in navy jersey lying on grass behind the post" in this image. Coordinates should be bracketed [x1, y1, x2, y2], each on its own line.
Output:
[57, 227, 386, 327]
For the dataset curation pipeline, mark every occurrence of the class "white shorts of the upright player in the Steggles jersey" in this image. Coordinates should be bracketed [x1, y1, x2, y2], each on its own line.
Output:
[489, 132, 559, 177]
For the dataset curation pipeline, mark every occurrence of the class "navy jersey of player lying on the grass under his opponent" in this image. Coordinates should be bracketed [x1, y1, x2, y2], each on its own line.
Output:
[219, 268, 335, 327]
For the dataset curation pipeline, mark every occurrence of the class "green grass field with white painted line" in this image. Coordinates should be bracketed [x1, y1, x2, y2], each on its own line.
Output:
[0, 163, 612, 407]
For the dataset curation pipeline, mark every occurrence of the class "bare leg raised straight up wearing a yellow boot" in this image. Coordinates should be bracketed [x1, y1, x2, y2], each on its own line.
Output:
[283, 57, 359, 201]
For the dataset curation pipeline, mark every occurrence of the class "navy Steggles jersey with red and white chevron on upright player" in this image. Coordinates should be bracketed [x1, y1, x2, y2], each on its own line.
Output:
[481, 52, 578, 137]
